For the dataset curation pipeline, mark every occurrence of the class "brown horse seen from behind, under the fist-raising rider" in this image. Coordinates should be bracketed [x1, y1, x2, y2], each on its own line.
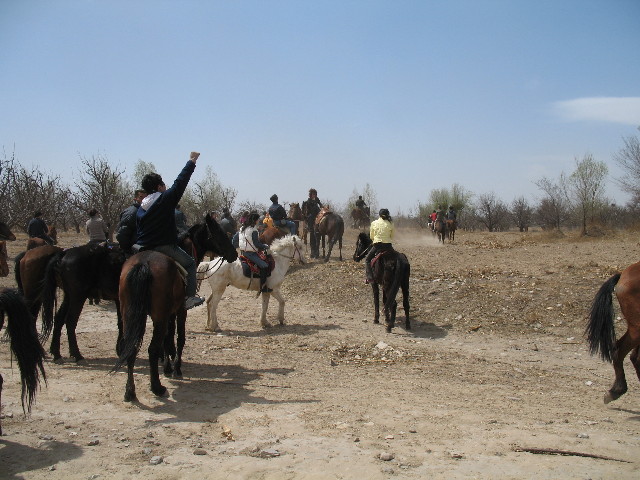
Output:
[111, 215, 238, 402]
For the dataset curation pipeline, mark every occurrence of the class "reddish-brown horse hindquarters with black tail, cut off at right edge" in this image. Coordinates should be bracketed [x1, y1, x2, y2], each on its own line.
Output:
[586, 262, 640, 403]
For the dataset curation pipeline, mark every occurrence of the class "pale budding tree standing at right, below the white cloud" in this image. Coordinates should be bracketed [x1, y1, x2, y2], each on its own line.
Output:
[569, 154, 609, 235]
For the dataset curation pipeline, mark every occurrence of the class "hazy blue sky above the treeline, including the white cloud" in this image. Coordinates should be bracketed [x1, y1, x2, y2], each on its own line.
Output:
[0, 0, 640, 214]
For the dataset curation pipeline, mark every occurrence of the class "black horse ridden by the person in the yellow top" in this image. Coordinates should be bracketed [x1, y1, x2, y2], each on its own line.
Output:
[353, 232, 411, 333]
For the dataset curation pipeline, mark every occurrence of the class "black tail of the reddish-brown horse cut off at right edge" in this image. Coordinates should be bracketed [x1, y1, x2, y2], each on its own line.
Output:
[585, 273, 620, 362]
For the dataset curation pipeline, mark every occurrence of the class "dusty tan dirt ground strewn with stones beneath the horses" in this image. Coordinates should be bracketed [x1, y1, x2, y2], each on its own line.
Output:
[0, 226, 640, 480]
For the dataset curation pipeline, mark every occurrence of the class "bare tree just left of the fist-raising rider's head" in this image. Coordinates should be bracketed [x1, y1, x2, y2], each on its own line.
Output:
[73, 154, 132, 234]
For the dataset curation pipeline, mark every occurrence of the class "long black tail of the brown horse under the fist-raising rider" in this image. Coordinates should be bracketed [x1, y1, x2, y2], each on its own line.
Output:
[111, 263, 152, 372]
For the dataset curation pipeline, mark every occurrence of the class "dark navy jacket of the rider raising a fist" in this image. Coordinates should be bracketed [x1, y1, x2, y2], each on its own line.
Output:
[136, 160, 196, 248]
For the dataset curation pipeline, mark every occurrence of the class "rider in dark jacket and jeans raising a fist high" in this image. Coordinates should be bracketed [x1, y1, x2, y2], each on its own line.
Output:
[136, 152, 205, 310]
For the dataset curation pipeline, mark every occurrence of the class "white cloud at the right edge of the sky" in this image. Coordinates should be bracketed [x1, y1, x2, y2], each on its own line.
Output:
[553, 97, 640, 125]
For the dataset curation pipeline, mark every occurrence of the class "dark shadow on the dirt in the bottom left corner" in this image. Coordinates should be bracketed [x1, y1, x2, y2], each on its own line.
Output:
[0, 438, 83, 480]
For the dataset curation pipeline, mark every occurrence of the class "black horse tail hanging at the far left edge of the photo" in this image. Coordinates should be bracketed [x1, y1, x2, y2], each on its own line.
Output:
[0, 288, 47, 436]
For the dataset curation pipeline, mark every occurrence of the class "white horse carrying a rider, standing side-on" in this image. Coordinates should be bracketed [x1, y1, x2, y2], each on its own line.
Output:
[197, 235, 306, 332]
